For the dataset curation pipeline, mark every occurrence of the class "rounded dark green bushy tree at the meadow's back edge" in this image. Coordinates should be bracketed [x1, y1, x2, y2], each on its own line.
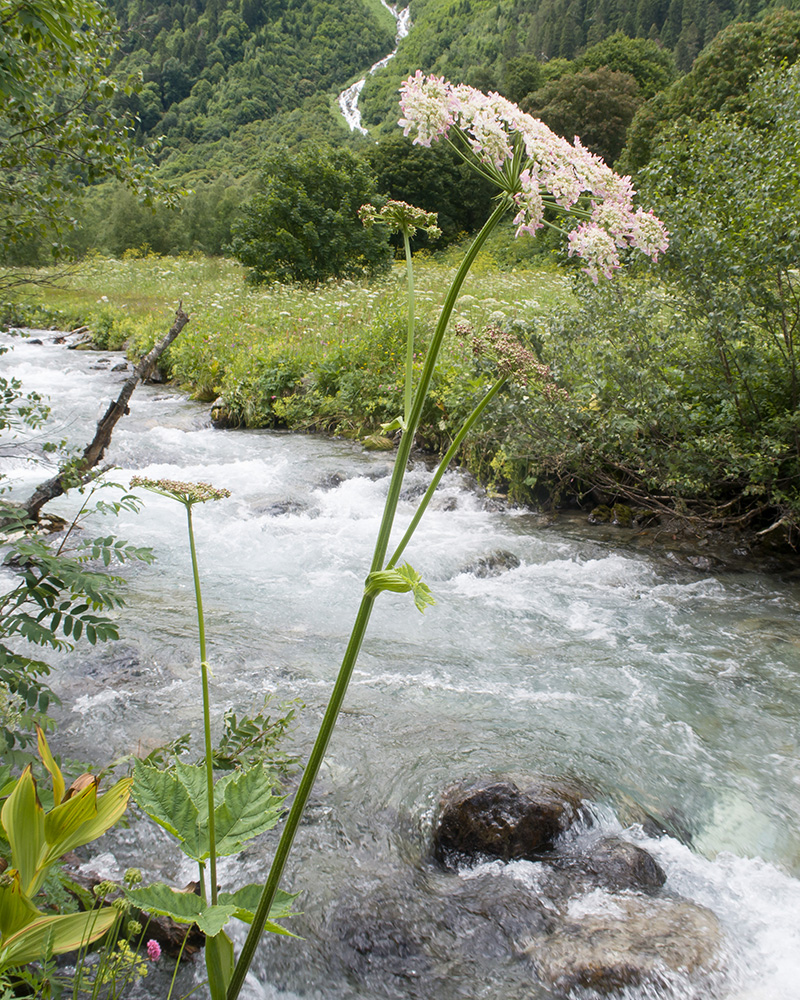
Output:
[230, 147, 389, 282]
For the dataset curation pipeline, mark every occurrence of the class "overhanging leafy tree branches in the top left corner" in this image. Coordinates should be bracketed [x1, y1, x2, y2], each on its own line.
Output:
[0, 0, 165, 262]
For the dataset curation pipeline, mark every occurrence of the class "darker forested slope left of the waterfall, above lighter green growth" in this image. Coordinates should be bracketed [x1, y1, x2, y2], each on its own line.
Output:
[105, 0, 395, 173]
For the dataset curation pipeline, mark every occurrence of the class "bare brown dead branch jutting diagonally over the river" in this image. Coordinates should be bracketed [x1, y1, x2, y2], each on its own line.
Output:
[23, 302, 189, 520]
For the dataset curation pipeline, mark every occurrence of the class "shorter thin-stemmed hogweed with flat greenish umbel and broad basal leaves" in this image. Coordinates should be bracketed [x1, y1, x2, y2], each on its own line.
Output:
[125, 476, 292, 1000]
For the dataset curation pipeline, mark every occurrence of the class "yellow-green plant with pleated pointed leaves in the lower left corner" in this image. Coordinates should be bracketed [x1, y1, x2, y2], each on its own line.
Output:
[0, 729, 133, 975]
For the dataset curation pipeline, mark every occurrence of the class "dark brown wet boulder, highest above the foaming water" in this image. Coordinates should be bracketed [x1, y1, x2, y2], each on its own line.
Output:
[433, 781, 580, 867]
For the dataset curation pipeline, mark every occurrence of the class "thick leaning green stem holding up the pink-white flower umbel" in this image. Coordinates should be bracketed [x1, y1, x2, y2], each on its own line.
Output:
[227, 197, 509, 1000]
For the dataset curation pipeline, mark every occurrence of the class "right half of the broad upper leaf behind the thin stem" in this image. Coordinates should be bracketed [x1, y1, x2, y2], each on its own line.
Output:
[209, 765, 283, 856]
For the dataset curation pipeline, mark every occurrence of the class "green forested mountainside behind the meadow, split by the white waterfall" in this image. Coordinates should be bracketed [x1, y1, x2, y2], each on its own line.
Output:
[0, 0, 800, 264]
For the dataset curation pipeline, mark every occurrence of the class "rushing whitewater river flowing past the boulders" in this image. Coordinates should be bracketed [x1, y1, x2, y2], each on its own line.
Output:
[0, 334, 800, 1000]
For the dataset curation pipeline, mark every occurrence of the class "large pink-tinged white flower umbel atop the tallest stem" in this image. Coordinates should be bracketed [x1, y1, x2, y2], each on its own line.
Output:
[400, 71, 669, 282]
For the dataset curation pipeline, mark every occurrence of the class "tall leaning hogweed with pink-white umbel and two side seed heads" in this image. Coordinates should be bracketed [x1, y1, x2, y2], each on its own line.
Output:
[178, 80, 668, 1000]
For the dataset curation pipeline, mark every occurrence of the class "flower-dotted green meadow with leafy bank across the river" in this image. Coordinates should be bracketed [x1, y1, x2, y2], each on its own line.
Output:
[1, 249, 571, 468]
